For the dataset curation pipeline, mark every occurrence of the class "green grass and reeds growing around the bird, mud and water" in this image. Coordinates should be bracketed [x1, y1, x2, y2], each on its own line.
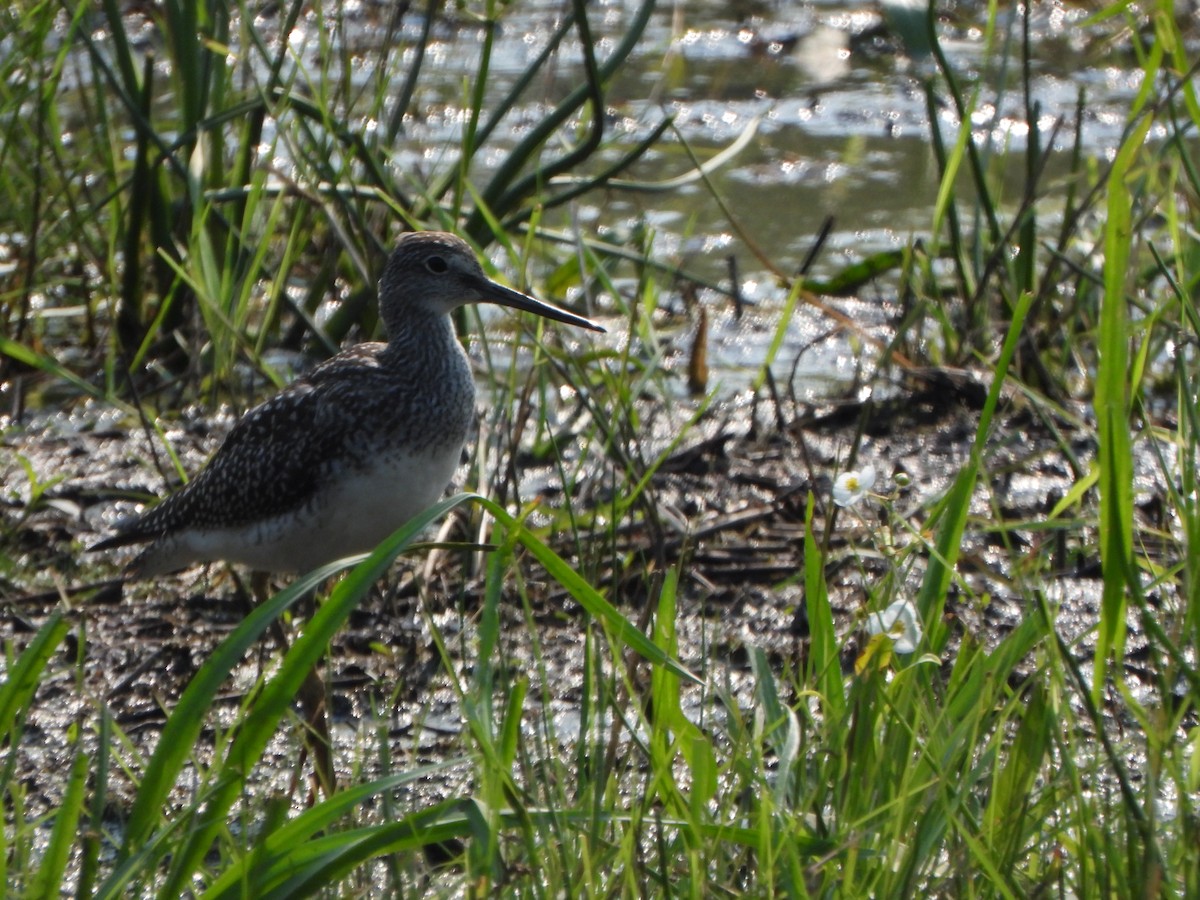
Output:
[0, 0, 1200, 896]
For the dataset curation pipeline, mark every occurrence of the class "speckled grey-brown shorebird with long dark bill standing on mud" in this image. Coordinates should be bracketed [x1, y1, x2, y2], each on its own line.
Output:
[91, 232, 604, 577]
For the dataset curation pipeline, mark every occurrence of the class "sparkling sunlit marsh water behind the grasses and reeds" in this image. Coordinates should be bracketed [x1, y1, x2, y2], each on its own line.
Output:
[7, 0, 1200, 406]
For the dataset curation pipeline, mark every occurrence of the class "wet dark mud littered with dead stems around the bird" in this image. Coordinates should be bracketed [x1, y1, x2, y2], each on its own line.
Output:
[2, 364, 1154, 830]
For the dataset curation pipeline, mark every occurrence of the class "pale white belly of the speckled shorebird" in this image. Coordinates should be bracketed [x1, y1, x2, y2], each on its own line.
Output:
[186, 450, 460, 572]
